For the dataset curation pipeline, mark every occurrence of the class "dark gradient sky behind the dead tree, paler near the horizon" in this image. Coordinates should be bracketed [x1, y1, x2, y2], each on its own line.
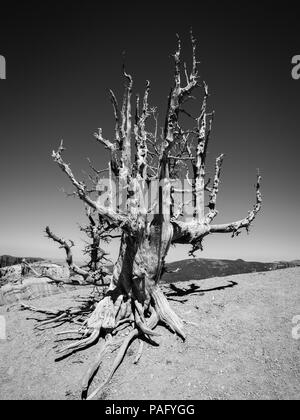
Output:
[0, 1, 300, 261]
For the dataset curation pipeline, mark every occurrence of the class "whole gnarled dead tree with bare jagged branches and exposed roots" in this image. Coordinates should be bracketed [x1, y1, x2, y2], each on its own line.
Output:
[24, 33, 262, 398]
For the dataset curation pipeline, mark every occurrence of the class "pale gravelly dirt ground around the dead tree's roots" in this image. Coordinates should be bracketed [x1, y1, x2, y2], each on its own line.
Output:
[0, 268, 300, 400]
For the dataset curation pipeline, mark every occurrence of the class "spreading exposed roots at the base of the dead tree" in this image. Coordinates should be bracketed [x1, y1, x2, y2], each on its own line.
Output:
[21, 287, 185, 400]
